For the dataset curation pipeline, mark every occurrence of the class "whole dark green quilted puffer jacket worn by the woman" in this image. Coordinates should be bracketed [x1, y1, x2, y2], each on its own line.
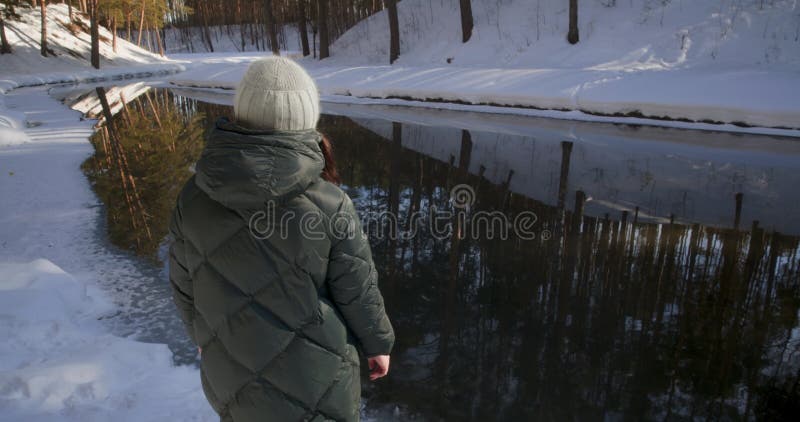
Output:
[169, 120, 394, 422]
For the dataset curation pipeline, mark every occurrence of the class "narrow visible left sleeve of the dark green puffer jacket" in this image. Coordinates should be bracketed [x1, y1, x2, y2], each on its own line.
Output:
[169, 204, 197, 344]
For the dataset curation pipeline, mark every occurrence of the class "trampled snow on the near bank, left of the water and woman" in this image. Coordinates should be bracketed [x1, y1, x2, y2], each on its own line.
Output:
[0, 88, 216, 421]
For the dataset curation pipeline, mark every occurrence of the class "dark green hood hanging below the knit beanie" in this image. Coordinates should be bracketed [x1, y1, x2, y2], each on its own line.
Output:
[195, 119, 325, 209]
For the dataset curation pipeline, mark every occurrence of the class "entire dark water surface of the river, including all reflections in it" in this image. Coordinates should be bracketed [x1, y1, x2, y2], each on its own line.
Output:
[75, 90, 800, 421]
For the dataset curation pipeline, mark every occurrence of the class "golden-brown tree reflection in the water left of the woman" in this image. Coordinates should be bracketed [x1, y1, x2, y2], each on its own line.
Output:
[83, 91, 222, 258]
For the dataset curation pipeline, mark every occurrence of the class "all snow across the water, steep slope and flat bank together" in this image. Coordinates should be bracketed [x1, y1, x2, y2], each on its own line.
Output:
[172, 0, 800, 130]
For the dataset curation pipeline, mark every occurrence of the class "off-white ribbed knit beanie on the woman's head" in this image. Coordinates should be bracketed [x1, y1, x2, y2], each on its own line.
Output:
[233, 56, 319, 130]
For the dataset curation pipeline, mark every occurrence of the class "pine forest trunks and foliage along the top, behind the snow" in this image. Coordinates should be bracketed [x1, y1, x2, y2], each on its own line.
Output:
[0, 0, 580, 63]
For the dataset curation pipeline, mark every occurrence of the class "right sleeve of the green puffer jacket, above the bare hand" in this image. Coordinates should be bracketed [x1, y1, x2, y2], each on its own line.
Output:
[326, 195, 394, 357]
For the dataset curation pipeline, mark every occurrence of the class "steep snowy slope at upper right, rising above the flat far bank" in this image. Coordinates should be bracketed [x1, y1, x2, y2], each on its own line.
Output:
[329, 0, 800, 71]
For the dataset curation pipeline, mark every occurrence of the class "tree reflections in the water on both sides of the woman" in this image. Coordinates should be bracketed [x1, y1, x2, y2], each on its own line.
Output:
[85, 91, 800, 421]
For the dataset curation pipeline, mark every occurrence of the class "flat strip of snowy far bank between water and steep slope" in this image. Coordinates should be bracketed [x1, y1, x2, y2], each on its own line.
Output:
[171, 61, 800, 136]
